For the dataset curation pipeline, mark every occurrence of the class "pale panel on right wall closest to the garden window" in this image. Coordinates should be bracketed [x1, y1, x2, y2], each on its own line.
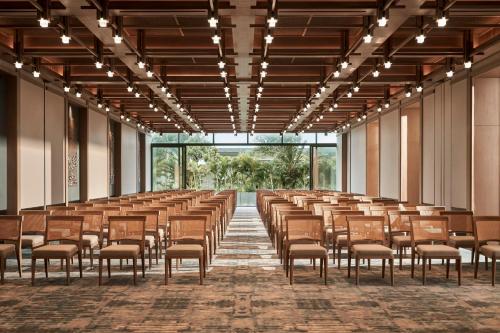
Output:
[350, 123, 366, 194]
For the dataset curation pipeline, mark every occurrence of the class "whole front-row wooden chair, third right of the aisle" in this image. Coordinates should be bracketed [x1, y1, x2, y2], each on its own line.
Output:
[410, 216, 462, 285]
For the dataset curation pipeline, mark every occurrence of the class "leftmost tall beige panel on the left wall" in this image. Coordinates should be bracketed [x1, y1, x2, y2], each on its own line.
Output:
[19, 80, 44, 208]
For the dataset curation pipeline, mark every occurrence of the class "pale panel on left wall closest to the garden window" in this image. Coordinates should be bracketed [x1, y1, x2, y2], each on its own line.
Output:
[121, 124, 138, 194]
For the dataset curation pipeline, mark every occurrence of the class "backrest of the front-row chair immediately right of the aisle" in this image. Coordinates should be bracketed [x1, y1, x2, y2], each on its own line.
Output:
[285, 215, 324, 245]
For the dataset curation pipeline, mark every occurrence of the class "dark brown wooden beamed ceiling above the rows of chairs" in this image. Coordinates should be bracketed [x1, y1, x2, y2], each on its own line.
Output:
[0, 0, 500, 133]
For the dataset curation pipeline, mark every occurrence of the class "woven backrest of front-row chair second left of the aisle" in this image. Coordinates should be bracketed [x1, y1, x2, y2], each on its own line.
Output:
[108, 216, 146, 246]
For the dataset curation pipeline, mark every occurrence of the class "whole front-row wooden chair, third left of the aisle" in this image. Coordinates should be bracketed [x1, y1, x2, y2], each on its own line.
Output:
[31, 216, 83, 285]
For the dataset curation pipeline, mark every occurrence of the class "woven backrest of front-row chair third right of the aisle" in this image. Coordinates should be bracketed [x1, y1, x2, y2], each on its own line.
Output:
[410, 215, 449, 245]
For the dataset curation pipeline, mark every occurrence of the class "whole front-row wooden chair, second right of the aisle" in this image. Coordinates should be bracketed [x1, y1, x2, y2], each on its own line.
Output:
[347, 216, 394, 286]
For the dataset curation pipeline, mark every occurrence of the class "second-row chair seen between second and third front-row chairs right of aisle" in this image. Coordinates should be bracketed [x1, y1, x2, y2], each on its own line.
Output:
[388, 210, 420, 269]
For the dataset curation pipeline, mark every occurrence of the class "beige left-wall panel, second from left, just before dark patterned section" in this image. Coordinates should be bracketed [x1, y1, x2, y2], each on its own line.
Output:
[45, 90, 66, 205]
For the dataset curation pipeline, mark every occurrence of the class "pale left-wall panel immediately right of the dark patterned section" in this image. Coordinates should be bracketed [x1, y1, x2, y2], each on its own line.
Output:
[87, 110, 108, 199]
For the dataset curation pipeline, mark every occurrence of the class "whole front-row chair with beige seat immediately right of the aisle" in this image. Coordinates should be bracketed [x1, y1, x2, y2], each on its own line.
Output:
[285, 215, 328, 285]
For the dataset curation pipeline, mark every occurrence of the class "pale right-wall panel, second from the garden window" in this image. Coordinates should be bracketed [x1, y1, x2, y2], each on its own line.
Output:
[379, 110, 401, 199]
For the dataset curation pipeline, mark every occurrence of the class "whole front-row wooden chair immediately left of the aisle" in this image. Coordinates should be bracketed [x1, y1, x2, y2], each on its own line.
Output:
[165, 215, 207, 285]
